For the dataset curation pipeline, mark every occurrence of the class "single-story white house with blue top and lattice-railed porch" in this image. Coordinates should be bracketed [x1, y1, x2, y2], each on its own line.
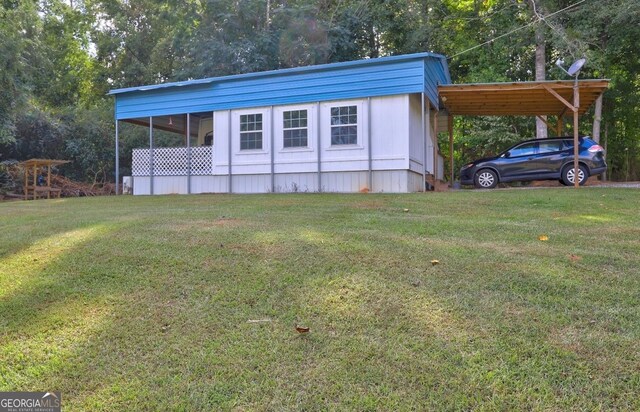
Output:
[110, 53, 451, 195]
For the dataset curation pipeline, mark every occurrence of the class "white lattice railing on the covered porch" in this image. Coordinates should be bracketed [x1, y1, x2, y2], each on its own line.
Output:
[131, 146, 213, 176]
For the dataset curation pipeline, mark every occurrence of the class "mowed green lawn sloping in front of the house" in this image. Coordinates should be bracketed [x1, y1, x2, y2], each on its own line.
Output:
[0, 188, 640, 410]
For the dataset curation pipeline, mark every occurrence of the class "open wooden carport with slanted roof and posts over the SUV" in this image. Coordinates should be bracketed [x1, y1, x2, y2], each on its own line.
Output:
[438, 80, 609, 187]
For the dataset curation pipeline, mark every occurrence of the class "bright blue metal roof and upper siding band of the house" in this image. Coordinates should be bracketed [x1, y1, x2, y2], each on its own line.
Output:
[109, 53, 451, 120]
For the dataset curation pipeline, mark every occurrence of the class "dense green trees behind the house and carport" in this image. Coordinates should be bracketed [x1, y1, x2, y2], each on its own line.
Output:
[0, 0, 640, 180]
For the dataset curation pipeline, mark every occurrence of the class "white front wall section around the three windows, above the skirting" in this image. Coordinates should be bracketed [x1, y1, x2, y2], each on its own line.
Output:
[213, 95, 409, 184]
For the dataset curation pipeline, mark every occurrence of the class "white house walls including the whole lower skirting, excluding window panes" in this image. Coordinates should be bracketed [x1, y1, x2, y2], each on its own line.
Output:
[134, 94, 424, 194]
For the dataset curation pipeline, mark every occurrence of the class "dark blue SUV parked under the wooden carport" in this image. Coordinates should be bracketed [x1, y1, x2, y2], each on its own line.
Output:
[460, 136, 607, 189]
